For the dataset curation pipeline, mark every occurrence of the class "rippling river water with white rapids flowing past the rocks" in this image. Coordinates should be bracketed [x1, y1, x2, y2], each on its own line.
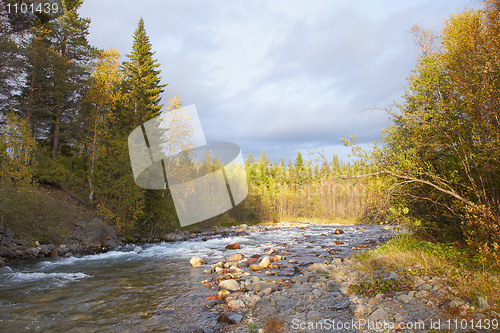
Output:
[0, 225, 391, 332]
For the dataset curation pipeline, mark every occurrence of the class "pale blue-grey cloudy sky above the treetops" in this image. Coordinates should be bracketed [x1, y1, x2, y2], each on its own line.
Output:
[80, 0, 481, 161]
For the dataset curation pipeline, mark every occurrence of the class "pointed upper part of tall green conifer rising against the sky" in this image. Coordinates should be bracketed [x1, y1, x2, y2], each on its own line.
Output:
[123, 18, 167, 126]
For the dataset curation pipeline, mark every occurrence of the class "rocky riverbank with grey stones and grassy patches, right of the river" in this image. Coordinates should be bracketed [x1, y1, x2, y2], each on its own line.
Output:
[189, 224, 500, 332]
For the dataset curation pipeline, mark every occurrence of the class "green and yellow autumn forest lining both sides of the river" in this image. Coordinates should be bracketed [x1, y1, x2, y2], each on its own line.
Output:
[0, 0, 500, 266]
